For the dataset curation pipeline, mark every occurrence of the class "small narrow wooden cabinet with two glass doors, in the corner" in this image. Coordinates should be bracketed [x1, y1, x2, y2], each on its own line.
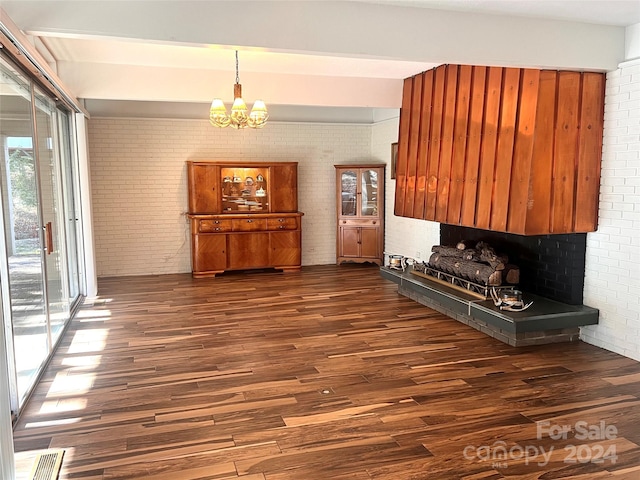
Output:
[335, 164, 385, 265]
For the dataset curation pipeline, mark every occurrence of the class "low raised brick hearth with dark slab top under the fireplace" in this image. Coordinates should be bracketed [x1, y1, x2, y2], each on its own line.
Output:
[380, 267, 598, 347]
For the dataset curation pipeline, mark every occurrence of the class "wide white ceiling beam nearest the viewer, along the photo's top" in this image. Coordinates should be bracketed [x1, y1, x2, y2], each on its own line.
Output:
[3, 0, 624, 71]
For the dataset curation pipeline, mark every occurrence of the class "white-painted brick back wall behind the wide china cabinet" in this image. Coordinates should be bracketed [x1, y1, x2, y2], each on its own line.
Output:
[89, 118, 371, 277]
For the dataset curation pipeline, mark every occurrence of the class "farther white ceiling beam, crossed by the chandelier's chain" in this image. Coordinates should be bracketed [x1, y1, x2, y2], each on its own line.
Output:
[58, 62, 403, 108]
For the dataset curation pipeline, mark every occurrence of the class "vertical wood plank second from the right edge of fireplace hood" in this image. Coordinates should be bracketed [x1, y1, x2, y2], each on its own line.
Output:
[551, 72, 580, 233]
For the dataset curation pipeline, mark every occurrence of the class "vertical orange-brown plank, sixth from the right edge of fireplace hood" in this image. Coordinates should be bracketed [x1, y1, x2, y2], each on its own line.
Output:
[475, 67, 502, 230]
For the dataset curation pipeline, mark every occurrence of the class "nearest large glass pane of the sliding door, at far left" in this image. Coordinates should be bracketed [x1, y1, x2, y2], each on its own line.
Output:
[0, 54, 49, 405]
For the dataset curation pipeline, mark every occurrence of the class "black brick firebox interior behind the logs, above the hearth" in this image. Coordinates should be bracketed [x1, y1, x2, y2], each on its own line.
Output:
[440, 224, 587, 305]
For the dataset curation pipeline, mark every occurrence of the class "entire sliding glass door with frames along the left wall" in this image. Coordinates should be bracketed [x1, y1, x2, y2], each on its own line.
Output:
[0, 50, 79, 413]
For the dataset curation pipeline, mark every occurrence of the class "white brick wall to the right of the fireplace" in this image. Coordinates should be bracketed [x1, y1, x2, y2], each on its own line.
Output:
[581, 60, 640, 360]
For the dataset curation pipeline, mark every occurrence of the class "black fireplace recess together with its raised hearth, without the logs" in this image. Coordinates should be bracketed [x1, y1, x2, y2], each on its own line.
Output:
[380, 224, 599, 347]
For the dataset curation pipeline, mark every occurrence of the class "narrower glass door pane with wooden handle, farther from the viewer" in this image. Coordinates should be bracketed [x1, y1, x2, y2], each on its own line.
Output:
[35, 89, 70, 343]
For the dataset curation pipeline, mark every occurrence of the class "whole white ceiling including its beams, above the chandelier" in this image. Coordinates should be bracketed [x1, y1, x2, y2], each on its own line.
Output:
[1, 0, 640, 122]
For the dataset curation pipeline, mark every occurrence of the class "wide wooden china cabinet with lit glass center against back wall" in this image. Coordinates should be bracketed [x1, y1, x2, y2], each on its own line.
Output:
[187, 161, 303, 278]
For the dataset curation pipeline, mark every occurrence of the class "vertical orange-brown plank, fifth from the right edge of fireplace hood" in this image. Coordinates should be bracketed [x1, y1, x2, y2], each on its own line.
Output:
[490, 68, 521, 232]
